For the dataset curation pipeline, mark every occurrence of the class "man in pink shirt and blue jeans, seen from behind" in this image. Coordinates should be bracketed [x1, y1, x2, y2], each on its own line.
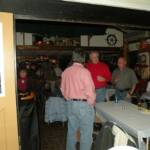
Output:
[61, 51, 96, 150]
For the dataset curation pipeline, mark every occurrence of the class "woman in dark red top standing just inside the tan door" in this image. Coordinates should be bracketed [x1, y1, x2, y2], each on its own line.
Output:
[17, 69, 39, 150]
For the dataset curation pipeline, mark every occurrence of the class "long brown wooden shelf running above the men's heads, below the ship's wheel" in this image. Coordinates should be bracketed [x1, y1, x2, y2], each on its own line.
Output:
[16, 46, 121, 56]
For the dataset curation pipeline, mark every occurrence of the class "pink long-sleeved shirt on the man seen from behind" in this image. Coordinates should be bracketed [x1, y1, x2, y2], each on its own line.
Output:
[61, 63, 96, 105]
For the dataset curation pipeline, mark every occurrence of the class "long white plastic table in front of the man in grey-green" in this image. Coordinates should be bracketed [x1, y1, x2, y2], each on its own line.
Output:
[96, 101, 150, 150]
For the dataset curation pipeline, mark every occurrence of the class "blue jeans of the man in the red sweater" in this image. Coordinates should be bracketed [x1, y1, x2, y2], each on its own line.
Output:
[96, 88, 106, 103]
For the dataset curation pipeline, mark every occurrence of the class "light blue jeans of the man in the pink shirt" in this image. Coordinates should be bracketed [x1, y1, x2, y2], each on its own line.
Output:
[66, 101, 94, 150]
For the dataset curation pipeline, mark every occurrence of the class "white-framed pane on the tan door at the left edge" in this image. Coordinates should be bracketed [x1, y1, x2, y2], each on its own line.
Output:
[0, 22, 5, 97]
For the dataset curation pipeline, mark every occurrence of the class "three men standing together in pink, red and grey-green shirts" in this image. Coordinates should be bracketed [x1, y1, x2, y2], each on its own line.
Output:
[61, 51, 138, 150]
